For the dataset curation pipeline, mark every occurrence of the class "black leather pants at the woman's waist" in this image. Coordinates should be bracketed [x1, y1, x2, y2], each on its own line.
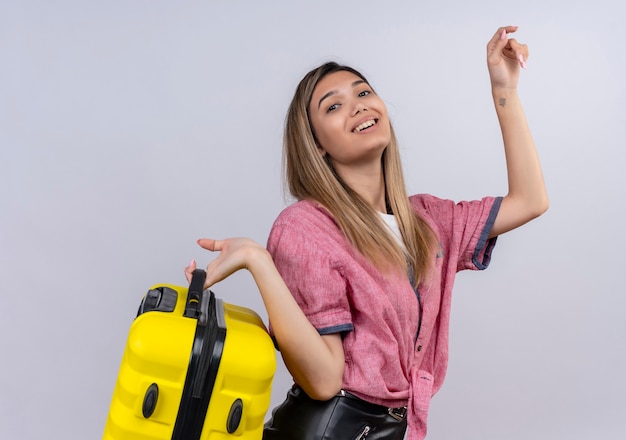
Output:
[263, 387, 406, 440]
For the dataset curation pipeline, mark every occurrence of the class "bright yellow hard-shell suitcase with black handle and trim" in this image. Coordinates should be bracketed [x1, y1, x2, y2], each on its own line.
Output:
[103, 270, 276, 440]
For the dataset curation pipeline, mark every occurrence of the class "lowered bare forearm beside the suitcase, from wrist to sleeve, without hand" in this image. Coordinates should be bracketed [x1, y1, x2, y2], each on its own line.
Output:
[248, 249, 344, 400]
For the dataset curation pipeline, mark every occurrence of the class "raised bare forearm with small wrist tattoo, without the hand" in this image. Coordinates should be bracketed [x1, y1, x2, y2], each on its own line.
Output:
[492, 88, 548, 236]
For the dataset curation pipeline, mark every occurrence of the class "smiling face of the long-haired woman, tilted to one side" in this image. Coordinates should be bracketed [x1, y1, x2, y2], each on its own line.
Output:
[309, 71, 391, 167]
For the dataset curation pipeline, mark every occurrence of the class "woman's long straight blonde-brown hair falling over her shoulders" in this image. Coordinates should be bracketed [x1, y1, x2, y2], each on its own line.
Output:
[283, 62, 435, 286]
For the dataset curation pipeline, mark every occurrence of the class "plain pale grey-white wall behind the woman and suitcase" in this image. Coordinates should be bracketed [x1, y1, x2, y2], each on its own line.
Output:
[0, 0, 626, 440]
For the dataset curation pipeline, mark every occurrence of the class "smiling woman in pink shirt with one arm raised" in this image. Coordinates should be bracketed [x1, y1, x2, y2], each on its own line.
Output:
[186, 26, 548, 440]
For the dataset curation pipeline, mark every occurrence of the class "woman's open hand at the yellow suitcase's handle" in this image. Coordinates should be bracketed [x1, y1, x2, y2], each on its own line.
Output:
[185, 237, 267, 289]
